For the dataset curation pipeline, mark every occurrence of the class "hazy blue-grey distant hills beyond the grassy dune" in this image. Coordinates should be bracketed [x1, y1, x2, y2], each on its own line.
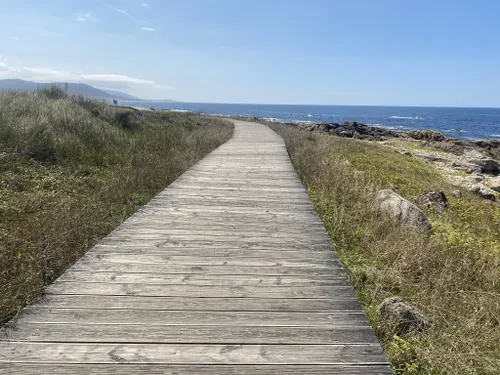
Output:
[0, 79, 140, 100]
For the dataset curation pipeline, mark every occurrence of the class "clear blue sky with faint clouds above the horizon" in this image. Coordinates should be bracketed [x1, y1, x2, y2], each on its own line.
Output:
[0, 0, 500, 107]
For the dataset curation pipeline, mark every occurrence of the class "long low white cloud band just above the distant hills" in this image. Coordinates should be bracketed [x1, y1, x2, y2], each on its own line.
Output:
[0, 60, 171, 90]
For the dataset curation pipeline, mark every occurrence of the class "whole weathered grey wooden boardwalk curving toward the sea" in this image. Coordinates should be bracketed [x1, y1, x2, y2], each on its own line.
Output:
[0, 121, 391, 375]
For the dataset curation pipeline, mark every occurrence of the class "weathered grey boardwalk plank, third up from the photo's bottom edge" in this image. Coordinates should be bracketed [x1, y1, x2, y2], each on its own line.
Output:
[4, 322, 378, 345]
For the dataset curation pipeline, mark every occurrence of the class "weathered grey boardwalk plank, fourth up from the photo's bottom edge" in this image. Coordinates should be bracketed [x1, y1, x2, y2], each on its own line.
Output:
[16, 306, 368, 328]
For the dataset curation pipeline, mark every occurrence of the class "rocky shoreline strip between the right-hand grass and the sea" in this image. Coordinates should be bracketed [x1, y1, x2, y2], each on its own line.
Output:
[262, 119, 500, 202]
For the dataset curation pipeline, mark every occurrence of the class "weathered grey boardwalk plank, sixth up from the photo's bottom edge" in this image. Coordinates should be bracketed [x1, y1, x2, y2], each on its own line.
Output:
[46, 280, 354, 298]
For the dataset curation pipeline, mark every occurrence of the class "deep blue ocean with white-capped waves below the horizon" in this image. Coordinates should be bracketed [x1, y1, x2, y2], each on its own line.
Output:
[120, 101, 500, 140]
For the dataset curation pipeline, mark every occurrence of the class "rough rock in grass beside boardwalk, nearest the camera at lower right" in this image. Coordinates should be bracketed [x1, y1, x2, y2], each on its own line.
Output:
[378, 297, 431, 337]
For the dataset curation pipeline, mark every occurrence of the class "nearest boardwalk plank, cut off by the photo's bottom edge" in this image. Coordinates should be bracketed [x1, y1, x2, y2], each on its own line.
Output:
[0, 362, 392, 375]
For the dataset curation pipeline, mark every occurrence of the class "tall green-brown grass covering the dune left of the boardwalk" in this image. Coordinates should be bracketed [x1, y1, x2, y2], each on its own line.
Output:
[0, 88, 232, 322]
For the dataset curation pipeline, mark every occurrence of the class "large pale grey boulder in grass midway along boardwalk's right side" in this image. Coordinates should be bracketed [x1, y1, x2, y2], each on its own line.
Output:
[375, 189, 432, 235]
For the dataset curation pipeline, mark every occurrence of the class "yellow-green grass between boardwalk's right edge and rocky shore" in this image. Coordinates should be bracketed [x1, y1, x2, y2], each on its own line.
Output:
[270, 124, 500, 375]
